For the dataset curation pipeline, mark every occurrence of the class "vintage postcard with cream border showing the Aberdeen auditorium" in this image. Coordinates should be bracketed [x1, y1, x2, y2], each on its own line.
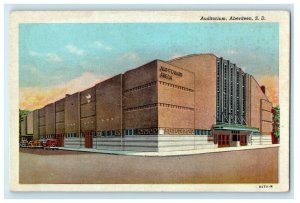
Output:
[9, 10, 290, 192]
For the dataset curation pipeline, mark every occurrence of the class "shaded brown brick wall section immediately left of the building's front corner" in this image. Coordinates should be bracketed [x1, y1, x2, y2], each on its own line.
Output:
[123, 61, 158, 129]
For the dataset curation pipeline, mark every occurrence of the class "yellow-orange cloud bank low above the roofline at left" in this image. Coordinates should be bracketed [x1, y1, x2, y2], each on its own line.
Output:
[19, 72, 108, 110]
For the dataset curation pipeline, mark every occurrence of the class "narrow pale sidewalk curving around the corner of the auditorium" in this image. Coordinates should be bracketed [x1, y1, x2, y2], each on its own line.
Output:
[58, 144, 279, 157]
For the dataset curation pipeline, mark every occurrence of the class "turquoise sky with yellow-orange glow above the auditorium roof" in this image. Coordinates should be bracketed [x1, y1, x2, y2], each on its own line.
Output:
[19, 23, 279, 110]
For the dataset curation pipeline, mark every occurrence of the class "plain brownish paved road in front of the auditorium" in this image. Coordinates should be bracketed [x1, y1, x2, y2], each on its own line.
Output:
[20, 148, 278, 184]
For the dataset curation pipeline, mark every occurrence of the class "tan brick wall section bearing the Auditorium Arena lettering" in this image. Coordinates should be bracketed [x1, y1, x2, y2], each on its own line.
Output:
[157, 61, 195, 129]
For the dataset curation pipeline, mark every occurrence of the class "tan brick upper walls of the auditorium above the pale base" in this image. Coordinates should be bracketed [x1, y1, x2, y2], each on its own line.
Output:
[25, 54, 272, 146]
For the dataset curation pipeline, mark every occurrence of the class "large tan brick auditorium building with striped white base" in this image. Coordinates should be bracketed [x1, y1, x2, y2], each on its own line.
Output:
[21, 54, 272, 151]
